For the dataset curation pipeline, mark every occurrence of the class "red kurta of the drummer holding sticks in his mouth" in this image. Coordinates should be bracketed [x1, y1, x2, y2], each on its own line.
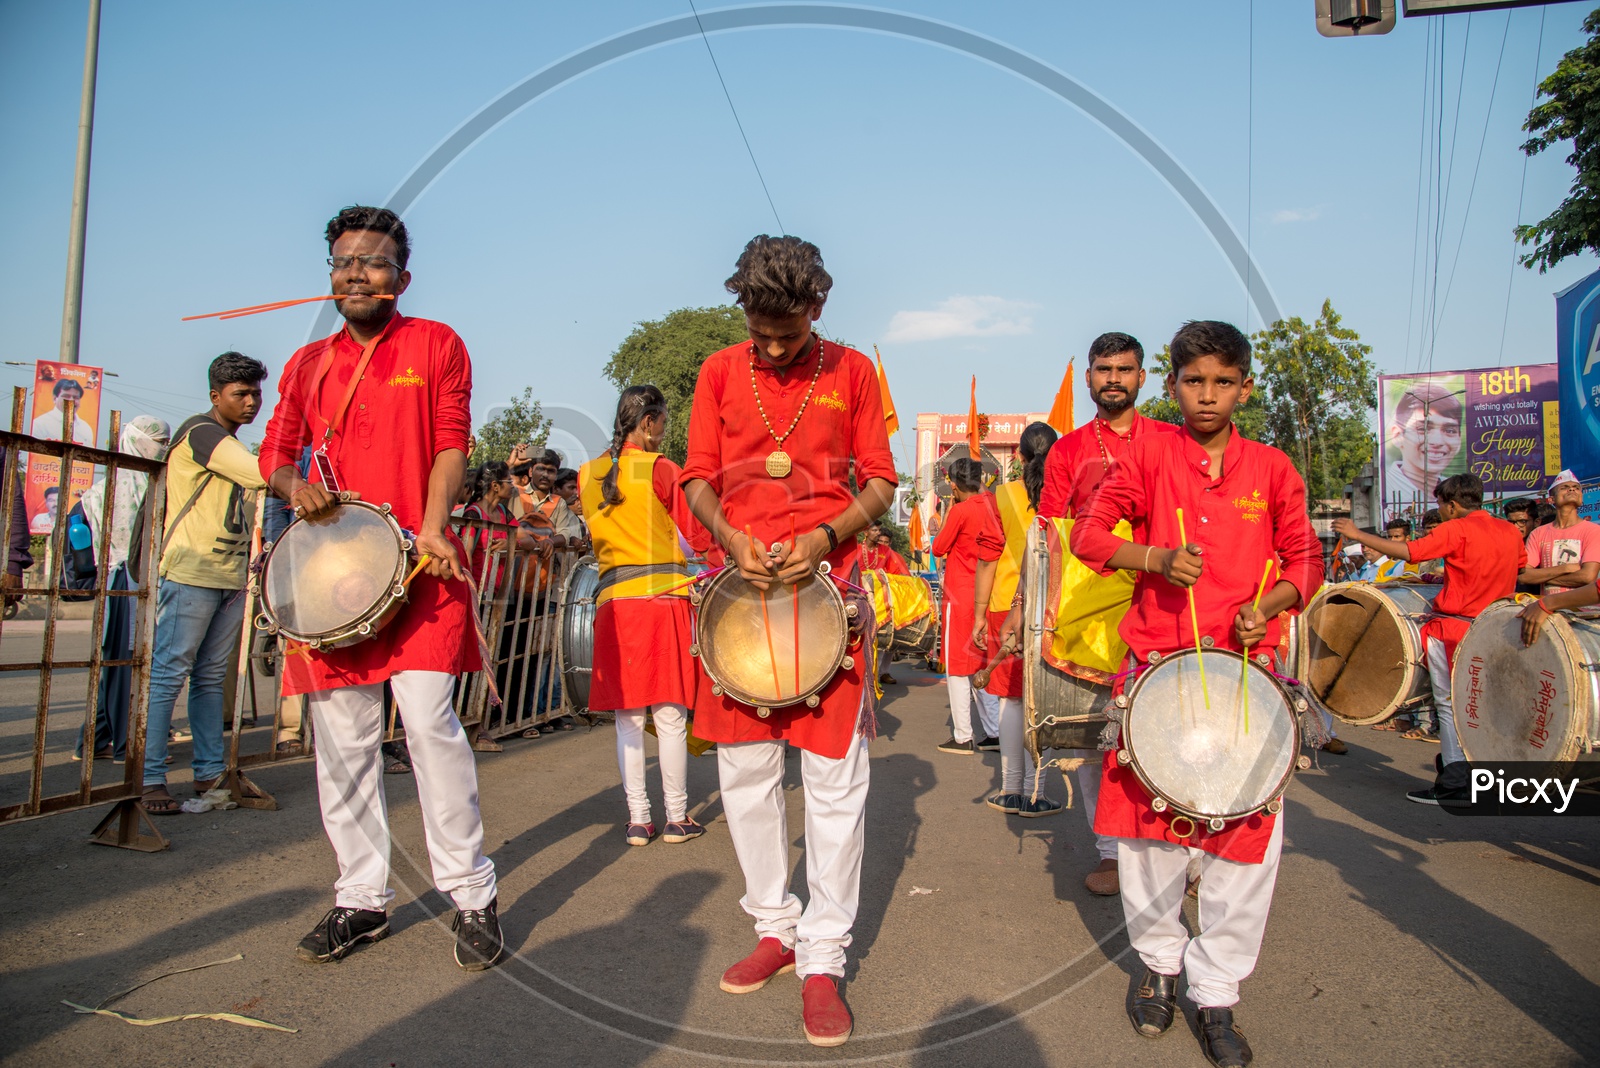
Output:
[261, 313, 480, 695]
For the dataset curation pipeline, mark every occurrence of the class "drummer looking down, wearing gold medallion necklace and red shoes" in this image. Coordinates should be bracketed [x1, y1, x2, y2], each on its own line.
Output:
[683, 235, 896, 1046]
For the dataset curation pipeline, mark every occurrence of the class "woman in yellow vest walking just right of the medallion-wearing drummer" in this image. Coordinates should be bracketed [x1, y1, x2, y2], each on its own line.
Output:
[973, 422, 1062, 817]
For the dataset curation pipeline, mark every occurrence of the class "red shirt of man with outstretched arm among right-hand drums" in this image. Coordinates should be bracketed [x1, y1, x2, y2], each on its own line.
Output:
[1406, 508, 1528, 656]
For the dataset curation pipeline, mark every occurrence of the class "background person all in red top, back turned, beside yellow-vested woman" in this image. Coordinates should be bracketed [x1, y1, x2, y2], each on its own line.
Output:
[933, 456, 1005, 753]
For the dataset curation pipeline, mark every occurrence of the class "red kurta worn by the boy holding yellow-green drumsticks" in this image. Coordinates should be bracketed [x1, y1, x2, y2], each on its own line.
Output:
[1072, 427, 1323, 863]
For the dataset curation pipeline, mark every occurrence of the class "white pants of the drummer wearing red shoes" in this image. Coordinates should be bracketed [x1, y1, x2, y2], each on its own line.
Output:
[717, 735, 870, 978]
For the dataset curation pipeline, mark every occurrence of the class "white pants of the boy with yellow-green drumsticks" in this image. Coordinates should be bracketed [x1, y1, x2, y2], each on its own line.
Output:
[1117, 812, 1283, 1009]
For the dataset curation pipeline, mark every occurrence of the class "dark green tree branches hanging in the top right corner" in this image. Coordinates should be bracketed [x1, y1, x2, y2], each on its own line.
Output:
[1517, 8, 1600, 273]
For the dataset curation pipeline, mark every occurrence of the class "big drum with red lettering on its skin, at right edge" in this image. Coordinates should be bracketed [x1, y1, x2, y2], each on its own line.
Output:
[1450, 598, 1600, 761]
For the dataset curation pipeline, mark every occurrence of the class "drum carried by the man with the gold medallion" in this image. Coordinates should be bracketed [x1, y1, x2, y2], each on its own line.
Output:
[690, 563, 859, 719]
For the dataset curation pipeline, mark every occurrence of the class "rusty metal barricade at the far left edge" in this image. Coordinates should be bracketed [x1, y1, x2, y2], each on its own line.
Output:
[0, 389, 168, 852]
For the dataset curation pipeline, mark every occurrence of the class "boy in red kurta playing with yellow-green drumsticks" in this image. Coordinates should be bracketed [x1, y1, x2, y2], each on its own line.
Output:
[1072, 321, 1323, 1068]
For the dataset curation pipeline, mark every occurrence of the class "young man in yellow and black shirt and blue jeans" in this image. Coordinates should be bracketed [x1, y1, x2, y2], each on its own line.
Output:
[142, 352, 267, 815]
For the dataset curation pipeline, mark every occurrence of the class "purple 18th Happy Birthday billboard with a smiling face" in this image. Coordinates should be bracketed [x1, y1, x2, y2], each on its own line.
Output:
[1378, 363, 1562, 516]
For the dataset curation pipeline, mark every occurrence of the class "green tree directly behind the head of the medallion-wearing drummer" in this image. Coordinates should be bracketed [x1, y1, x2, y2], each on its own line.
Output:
[605, 304, 750, 464]
